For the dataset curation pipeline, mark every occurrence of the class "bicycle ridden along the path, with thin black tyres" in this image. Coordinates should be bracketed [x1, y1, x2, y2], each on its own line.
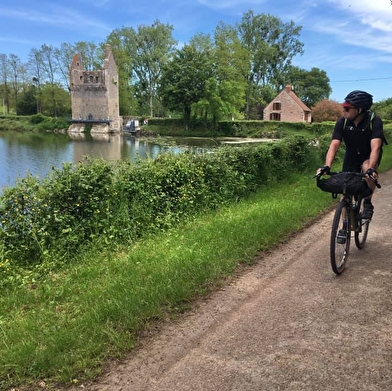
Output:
[316, 172, 381, 275]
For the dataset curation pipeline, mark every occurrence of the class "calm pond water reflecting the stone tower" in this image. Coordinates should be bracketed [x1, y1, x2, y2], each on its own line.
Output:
[0, 131, 217, 191]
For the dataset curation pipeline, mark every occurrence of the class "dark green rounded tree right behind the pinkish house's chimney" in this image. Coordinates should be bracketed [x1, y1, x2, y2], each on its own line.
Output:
[286, 66, 332, 107]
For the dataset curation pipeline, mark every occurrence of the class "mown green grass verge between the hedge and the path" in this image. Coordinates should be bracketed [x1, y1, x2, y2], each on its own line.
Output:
[0, 142, 392, 389]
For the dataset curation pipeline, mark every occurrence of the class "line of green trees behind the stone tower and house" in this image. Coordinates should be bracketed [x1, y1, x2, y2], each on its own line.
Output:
[0, 10, 388, 124]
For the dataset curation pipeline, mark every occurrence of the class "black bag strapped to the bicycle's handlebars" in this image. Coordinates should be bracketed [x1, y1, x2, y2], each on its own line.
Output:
[317, 172, 373, 197]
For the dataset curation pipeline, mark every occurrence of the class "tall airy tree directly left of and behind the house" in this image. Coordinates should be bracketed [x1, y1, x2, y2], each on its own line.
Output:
[237, 10, 303, 118]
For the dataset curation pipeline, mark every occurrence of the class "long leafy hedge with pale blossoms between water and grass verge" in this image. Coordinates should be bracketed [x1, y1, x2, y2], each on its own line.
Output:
[0, 136, 319, 285]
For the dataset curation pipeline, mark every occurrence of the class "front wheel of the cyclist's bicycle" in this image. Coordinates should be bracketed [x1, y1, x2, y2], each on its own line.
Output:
[330, 200, 351, 275]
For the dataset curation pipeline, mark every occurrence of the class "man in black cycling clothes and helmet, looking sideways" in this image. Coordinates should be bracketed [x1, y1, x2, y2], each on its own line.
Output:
[317, 90, 386, 243]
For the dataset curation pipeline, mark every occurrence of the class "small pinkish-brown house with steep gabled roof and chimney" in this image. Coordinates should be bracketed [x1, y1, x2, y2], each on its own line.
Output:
[263, 85, 312, 122]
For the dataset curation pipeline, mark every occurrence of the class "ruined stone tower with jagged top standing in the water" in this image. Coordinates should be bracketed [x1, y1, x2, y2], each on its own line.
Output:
[68, 45, 122, 133]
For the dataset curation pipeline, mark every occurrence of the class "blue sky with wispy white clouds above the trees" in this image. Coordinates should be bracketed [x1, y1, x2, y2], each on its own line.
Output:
[0, 0, 392, 102]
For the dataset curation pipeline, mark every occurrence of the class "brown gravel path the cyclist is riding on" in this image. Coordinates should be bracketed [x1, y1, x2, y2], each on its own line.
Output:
[71, 172, 392, 391]
